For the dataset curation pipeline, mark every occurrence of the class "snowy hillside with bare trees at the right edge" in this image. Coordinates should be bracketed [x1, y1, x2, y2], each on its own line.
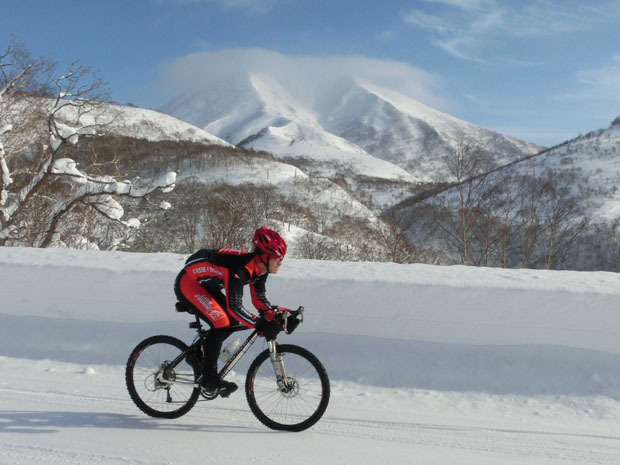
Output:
[392, 114, 620, 271]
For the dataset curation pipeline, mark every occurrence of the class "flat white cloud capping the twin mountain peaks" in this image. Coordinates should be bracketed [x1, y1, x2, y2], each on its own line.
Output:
[156, 48, 450, 110]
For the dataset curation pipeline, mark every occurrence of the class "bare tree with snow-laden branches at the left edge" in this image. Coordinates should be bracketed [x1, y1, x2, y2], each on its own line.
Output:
[0, 40, 176, 247]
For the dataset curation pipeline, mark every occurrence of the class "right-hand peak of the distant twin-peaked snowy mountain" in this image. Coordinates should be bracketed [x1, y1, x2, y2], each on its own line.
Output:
[322, 81, 542, 181]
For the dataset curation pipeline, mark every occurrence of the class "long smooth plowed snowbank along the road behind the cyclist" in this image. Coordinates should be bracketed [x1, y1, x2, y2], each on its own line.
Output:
[0, 248, 620, 399]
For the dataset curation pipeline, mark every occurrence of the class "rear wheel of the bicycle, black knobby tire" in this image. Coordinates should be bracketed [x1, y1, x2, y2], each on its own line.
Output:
[125, 336, 200, 418]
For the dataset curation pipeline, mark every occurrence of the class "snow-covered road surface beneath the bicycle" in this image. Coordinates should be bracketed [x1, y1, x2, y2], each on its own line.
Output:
[0, 358, 620, 465]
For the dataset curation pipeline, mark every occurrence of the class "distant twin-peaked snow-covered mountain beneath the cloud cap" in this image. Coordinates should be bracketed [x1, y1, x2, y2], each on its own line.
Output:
[162, 74, 541, 183]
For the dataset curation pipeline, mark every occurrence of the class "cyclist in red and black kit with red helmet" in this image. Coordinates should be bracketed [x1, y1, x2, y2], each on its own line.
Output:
[174, 226, 286, 397]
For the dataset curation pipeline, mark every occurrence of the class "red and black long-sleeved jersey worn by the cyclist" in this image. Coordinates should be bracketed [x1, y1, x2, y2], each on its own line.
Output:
[177, 249, 272, 327]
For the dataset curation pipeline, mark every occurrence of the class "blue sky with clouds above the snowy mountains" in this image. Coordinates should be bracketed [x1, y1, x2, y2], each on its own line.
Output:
[0, 0, 620, 145]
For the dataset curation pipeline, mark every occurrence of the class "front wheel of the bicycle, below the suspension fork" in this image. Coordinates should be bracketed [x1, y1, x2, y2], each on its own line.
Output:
[245, 344, 330, 431]
